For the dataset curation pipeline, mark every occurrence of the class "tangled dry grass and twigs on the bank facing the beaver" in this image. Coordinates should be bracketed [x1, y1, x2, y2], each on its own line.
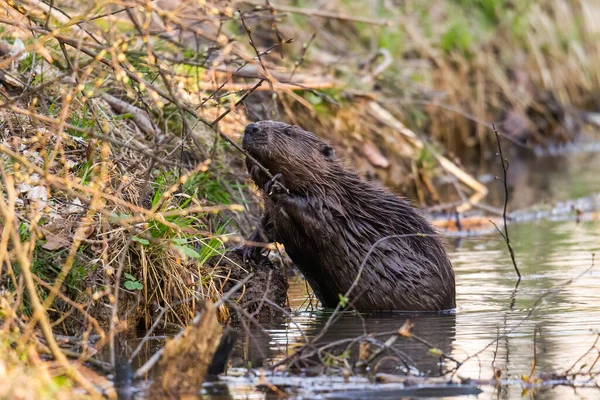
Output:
[0, 1, 292, 396]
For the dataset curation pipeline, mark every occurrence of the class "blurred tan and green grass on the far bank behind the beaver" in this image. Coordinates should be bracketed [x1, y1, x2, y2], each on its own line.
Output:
[251, 0, 600, 154]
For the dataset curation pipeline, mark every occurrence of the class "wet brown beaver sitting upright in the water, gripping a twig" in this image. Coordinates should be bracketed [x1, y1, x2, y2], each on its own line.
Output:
[242, 121, 455, 311]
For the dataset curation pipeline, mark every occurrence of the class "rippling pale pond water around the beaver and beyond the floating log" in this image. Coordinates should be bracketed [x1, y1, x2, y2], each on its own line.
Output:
[210, 154, 600, 399]
